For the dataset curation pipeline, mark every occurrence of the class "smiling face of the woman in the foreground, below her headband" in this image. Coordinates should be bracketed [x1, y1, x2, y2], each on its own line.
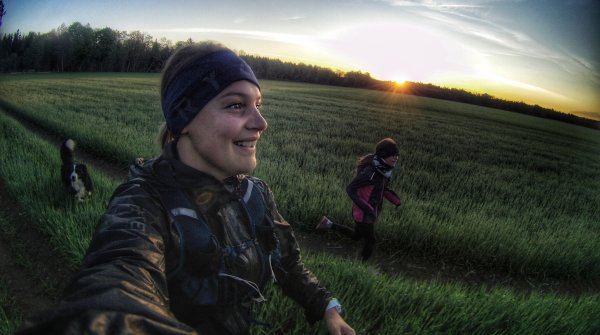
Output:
[177, 80, 267, 180]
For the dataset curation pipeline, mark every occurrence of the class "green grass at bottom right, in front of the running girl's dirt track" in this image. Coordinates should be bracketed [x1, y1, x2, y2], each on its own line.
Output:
[256, 254, 600, 334]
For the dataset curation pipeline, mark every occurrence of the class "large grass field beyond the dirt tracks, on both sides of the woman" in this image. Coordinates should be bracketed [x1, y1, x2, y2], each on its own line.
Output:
[0, 74, 600, 278]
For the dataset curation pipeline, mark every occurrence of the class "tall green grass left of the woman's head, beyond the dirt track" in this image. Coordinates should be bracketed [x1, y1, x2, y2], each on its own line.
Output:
[0, 74, 162, 162]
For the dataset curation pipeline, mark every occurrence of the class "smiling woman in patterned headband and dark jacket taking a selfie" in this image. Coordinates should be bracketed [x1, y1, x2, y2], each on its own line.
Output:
[19, 44, 354, 335]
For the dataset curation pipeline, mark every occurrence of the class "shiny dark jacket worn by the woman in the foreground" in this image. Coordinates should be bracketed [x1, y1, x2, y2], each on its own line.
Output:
[20, 142, 331, 334]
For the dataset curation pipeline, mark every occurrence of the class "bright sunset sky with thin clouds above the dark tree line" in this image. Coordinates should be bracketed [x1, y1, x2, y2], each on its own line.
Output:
[0, 0, 600, 120]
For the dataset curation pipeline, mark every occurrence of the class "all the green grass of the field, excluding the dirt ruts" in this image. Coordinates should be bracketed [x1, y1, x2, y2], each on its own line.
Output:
[0, 74, 600, 334]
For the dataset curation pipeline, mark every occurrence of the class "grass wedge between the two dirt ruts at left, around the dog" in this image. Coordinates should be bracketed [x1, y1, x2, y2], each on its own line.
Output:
[0, 113, 118, 266]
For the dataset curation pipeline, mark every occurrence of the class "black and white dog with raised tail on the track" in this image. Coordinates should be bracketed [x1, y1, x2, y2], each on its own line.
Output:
[60, 139, 93, 201]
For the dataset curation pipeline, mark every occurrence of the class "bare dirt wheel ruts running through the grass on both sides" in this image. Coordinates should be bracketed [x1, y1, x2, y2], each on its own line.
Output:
[0, 111, 600, 324]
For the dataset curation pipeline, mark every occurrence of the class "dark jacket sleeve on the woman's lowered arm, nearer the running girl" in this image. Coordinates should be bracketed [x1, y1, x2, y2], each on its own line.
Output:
[258, 185, 331, 324]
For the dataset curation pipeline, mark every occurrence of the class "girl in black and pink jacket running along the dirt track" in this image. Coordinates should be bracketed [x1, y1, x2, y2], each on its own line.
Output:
[316, 138, 400, 260]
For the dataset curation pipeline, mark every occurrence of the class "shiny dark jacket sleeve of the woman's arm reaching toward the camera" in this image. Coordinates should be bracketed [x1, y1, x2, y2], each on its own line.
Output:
[20, 184, 195, 334]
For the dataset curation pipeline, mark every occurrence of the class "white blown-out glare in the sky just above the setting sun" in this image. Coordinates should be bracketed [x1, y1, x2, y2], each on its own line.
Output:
[324, 23, 480, 84]
